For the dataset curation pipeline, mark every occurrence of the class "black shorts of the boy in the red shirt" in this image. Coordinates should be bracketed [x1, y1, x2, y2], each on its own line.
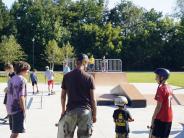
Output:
[152, 119, 172, 138]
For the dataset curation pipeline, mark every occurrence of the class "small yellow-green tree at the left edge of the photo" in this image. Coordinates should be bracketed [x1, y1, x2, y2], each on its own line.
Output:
[0, 35, 26, 63]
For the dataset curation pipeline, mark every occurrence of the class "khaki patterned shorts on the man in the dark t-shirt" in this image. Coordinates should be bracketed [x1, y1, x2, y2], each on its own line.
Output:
[57, 108, 92, 138]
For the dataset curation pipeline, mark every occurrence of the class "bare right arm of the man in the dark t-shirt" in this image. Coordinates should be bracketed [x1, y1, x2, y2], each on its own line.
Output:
[90, 89, 97, 123]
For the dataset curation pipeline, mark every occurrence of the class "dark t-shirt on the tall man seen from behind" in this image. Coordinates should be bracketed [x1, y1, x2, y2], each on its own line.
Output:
[61, 69, 95, 111]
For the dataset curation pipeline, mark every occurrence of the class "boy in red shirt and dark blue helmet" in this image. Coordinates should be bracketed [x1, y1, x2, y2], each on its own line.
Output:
[151, 68, 173, 138]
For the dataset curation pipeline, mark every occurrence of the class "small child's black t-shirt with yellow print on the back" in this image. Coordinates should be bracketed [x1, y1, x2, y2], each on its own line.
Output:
[113, 109, 132, 134]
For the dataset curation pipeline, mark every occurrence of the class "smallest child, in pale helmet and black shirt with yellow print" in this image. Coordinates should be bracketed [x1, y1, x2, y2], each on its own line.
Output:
[113, 96, 134, 138]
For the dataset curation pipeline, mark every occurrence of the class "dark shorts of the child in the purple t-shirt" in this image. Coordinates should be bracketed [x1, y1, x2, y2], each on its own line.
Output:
[9, 112, 25, 133]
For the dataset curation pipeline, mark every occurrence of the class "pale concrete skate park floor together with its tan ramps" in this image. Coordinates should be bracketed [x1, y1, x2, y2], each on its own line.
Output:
[0, 58, 184, 138]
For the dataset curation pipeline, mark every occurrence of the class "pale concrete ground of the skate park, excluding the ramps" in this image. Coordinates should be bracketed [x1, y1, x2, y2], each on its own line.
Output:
[0, 83, 184, 138]
